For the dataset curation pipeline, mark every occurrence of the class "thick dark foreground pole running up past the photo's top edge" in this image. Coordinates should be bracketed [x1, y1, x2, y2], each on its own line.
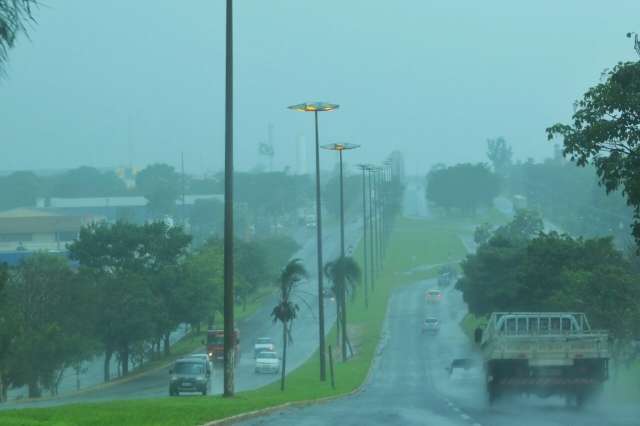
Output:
[223, 0, 236, 397]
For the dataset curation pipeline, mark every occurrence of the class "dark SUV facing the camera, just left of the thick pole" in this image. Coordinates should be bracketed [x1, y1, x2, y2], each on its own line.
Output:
[169, 357, 211, 396]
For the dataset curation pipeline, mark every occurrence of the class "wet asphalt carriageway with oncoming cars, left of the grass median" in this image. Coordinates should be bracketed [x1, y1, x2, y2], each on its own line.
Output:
[0, 222, 362, 410]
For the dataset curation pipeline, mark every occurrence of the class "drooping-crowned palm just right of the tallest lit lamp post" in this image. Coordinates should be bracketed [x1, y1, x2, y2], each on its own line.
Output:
[324, 256, 361, 362]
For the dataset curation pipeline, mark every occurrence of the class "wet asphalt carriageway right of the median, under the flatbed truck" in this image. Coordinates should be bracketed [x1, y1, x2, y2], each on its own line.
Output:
[239, 186, 640, 426]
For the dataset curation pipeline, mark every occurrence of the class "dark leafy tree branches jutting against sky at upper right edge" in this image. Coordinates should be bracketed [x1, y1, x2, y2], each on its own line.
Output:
[547, 62, 640, 246]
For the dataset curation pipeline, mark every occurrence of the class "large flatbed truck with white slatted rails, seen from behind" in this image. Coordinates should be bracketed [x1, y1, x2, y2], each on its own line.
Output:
[475, 312, 609, 406]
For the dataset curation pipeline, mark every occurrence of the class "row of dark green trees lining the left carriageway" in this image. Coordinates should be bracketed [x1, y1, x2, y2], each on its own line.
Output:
[0, 225, 298, 401]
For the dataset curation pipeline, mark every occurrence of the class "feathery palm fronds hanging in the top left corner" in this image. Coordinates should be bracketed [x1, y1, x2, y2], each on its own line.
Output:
[0, 0, 38, 72]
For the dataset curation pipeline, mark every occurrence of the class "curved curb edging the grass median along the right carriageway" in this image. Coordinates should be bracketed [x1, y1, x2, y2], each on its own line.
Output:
[202, 301, 389, 426]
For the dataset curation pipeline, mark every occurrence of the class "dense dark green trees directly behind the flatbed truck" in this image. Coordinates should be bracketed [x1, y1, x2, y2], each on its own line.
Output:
[457, 220, 640, 338]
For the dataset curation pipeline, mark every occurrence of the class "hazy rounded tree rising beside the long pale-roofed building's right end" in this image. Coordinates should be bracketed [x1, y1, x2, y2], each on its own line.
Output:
[136, 164, 181, 218]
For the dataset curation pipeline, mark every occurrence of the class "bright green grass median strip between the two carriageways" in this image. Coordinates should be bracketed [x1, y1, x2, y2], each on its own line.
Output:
[0, 218, 465, 426]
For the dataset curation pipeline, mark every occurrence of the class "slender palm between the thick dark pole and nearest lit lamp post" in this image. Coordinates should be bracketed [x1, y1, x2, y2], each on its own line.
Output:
[271, 259, 307, 390]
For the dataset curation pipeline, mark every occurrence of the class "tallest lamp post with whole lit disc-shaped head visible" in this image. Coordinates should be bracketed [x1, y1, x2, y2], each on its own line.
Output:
[289, 102, 339, 381]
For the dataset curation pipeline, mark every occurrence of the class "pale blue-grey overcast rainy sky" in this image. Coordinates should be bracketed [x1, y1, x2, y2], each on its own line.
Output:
[0, 0, 640, 174]
